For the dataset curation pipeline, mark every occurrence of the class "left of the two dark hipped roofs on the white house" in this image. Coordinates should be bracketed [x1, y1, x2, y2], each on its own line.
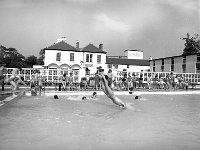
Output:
[45, 41, 79, 51]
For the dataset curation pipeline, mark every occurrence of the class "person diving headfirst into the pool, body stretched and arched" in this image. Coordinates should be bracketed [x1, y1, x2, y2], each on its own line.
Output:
[99, 70, 126, 108]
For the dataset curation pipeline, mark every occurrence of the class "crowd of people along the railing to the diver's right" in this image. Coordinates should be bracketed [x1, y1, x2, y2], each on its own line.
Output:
[109, 73, 189, 90]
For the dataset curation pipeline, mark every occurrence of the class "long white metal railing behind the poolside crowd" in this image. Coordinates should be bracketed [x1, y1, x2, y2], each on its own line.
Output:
[3, 68, 200, 84]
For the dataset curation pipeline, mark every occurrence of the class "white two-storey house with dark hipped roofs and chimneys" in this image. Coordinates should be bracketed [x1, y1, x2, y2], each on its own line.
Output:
[44, 39, 107, 77]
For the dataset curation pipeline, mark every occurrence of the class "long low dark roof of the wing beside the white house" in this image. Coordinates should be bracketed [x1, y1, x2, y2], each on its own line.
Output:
[106, 57, 150, 66]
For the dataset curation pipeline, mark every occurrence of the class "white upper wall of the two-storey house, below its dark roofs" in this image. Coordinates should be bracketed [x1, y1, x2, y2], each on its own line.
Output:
[44, 50, 107, 73]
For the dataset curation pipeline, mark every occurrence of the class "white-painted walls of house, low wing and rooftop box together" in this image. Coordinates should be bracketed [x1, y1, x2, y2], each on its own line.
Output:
[44, 37, 150, 81]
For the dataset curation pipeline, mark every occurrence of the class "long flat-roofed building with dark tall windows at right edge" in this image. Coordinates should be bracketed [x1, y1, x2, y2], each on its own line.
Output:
[149, 54, 200, 73]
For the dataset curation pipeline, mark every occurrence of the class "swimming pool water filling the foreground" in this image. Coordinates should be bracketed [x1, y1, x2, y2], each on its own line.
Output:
[0, 93, 200, 150]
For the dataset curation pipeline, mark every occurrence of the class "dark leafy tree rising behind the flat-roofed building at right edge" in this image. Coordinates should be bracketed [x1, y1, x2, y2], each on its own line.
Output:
[182, 33, 200, 55]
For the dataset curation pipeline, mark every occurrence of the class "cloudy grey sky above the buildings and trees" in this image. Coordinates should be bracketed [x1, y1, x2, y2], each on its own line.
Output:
[0, 0, 200, 59]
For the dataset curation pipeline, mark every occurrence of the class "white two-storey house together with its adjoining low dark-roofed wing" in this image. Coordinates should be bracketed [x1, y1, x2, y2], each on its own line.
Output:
[44, 37, 150, 76]
